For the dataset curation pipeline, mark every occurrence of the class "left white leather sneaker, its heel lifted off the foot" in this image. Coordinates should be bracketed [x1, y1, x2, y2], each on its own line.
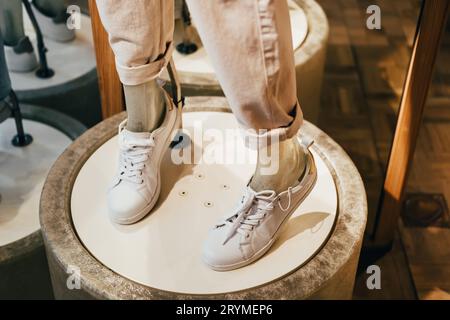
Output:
[108, 93, 181, 224]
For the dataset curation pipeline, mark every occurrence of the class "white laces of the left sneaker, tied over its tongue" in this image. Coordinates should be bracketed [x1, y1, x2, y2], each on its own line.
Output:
[118, 124, 155, 184]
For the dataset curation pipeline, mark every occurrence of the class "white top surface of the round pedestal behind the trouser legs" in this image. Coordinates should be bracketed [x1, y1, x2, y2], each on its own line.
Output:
[173, 0, 308, 74]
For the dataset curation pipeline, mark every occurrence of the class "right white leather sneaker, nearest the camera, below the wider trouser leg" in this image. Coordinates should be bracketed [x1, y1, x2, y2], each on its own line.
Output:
[203, 136, 317, 271]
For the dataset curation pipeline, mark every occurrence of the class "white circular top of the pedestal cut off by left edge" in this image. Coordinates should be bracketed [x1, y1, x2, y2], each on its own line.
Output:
[0, 119, 72, 247]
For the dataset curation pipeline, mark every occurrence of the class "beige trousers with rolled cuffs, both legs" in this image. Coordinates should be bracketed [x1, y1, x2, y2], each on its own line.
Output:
[97, 0, 303, 145]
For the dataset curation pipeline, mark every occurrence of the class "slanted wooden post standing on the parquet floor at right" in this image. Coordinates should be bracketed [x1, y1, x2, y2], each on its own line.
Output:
[373, 0, 449, 246]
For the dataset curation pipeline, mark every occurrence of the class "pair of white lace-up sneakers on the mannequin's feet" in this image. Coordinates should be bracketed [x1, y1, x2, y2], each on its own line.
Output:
[108, 90, 317, 271]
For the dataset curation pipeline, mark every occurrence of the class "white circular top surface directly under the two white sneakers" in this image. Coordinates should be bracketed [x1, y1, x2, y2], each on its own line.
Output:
[71, 112, 337, 294]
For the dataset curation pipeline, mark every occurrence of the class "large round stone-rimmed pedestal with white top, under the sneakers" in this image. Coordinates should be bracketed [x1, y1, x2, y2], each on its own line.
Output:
[41, 97, 367, 299]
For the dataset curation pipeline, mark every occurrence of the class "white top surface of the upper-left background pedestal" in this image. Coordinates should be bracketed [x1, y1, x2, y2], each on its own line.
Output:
[10, 11, 96, 92]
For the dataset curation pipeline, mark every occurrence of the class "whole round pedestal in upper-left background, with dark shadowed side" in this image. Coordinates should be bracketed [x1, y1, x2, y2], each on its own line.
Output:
[10, 13, 100, 124]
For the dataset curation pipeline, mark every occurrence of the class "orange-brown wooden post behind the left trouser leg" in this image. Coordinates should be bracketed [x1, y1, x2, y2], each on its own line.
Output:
[89, 0, 125, 119]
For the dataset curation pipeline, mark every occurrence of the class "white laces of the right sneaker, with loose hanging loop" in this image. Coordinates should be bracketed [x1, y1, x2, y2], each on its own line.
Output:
[221, 188, 292, 245]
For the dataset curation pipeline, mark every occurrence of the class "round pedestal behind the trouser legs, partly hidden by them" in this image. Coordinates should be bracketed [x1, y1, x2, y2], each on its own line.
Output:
[161, 0, 328, 123]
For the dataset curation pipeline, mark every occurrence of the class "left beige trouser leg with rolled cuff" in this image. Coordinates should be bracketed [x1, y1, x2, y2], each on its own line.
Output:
[96, 0, 174, 85]
